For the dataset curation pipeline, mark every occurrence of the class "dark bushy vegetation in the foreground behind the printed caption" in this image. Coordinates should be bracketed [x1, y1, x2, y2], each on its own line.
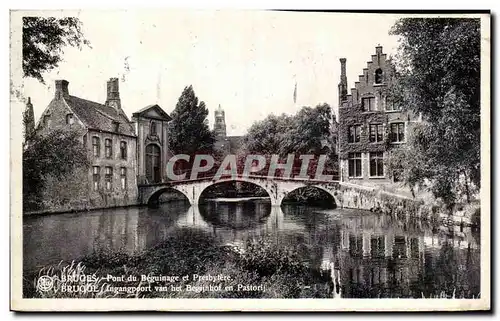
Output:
[23, 229, 332, 298]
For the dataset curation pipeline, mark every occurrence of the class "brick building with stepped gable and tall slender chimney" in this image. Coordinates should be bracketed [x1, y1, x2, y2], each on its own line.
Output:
[338, 46, 417, 183]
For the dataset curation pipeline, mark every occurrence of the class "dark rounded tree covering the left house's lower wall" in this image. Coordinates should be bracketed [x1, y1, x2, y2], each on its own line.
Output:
[23, 130, 89, 209]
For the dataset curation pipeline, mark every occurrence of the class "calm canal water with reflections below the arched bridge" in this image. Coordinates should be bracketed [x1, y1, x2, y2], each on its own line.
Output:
[23, 199, 480, 298]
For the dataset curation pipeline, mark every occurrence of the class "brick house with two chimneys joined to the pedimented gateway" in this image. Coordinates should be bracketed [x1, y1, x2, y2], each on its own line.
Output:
[36, 78, 170, 210]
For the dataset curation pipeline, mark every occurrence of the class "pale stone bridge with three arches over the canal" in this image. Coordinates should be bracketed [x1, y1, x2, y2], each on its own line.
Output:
[138, 176, 342, 206]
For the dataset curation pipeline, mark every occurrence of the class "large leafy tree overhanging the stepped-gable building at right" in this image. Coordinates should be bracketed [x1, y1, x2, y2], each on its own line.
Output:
[390, 18, 481, 205]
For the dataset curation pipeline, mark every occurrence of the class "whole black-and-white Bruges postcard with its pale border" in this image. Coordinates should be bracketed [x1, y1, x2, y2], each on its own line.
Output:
[10, 9, 491, 311]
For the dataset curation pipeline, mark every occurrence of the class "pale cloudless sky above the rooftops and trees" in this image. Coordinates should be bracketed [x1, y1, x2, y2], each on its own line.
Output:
[13, 9, 397, 135]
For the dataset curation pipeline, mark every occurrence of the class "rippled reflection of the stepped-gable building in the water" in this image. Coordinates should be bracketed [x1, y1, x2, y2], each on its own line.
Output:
[326, 217, 477, 297]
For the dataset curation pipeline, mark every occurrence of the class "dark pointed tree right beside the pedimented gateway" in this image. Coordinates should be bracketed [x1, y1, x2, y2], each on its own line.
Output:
[169, 86, 215, 156]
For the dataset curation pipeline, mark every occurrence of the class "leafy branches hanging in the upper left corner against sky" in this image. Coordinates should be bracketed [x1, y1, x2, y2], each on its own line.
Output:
[23, 17, 90, 83]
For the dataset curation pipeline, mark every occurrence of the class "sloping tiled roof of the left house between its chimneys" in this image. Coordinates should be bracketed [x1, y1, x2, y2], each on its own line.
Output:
[64, 96, 136, 136]
